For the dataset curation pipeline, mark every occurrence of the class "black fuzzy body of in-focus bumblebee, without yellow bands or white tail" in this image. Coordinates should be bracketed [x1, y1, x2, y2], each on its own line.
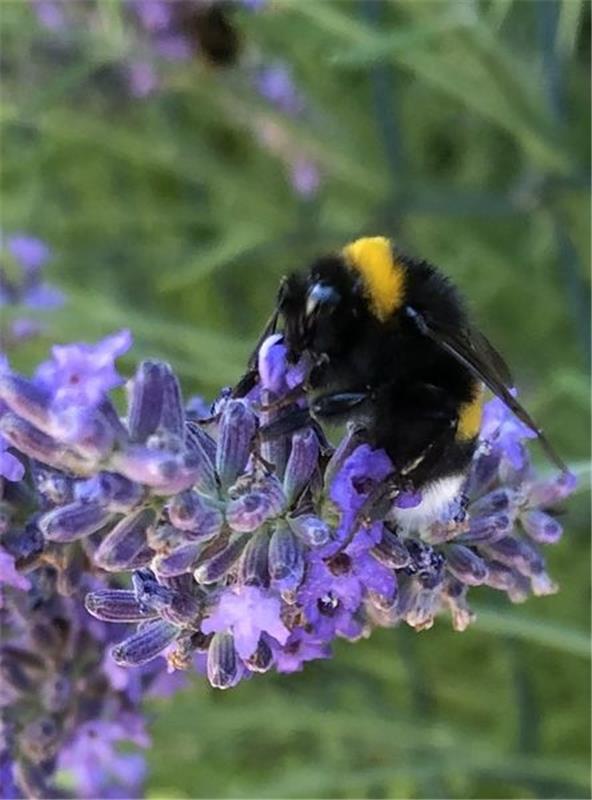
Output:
[280, 253, 479, 488]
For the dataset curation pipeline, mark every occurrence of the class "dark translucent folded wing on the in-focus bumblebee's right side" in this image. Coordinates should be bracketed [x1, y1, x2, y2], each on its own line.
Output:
[409, 309, 567, 472]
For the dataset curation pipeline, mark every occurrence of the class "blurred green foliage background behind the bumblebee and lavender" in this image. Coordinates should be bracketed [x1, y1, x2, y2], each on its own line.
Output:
[1, 0, 590, 798]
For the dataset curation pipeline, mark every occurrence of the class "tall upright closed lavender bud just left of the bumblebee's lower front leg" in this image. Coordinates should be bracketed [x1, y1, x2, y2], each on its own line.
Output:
[216, 400, 257, 491]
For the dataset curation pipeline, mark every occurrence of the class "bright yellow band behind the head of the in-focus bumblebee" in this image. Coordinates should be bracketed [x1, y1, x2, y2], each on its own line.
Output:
[342, 236, 405, 321]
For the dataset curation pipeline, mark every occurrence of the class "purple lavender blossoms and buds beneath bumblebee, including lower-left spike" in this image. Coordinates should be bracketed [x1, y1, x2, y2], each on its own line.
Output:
[0, 331, 575, 797]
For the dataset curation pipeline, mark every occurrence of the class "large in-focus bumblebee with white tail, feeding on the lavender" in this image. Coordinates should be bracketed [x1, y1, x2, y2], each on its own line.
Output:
[239, 237, 565, 522]
